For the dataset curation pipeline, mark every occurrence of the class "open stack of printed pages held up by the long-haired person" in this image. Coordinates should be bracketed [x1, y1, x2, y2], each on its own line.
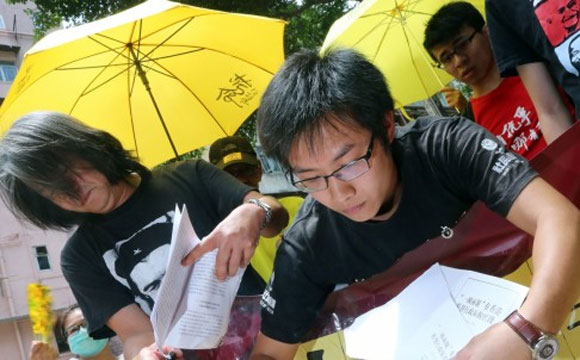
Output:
[151, 205, 245, 349]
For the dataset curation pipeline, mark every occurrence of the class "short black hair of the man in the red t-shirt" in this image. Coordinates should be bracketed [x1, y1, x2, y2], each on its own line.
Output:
[423, 1, 485, 61]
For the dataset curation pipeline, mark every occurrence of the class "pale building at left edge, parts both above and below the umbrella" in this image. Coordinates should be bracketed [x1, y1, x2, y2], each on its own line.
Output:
[0, 0, 75, 360]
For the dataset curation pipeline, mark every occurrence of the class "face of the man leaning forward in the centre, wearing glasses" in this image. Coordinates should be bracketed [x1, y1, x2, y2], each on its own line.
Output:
[289, 113, 398, 222]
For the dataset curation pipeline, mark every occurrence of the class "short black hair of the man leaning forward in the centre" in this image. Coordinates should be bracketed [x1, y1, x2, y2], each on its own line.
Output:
[258, 49, 393, 170]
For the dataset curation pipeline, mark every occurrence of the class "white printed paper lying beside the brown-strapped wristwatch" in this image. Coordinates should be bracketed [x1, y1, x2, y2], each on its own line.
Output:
[344, 264, 528, 360]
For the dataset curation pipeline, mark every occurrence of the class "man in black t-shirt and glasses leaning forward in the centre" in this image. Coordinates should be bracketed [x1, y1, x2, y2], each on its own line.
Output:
[251, 50, 580, 360]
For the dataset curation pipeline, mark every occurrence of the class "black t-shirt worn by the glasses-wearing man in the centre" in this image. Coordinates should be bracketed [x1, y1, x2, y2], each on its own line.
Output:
[261, 118, 537, 343]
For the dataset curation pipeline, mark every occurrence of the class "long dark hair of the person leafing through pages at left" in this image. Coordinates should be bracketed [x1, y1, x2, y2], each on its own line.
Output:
[0, 111, 150, 229]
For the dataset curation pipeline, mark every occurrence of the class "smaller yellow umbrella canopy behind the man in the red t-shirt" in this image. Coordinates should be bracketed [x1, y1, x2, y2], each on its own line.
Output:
[321, 0, 484, 106]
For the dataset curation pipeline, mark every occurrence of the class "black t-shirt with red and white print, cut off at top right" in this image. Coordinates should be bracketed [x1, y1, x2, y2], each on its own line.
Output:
[485, 0, 580, 116]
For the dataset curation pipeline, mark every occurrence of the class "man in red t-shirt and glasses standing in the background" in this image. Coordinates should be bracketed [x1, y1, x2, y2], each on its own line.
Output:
[423, 1, 573, 159]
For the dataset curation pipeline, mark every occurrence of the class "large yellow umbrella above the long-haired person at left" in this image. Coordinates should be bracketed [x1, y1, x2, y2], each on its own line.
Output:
[0, 0, 285, 166]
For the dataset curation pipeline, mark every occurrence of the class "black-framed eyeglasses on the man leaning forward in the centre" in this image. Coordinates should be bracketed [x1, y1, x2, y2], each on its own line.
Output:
[292, 136, 375, 193]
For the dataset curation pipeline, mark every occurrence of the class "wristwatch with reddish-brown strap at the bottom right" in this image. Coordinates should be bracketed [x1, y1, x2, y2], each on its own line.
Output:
[504, 310, 560, 360]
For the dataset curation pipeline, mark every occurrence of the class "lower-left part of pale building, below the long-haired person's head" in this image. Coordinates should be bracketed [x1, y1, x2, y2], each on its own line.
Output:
[0, 202, 75, 360]
